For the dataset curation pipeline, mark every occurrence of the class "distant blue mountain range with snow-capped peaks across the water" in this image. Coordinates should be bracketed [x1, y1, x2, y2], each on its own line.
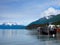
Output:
[0, 23, 26, 29]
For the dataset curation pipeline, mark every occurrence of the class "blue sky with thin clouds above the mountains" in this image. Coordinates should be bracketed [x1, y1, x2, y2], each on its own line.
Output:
[0, 0, 60, 25]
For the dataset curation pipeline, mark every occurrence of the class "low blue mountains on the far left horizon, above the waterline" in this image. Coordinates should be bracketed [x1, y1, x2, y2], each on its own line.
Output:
[0, 24, 26, 29]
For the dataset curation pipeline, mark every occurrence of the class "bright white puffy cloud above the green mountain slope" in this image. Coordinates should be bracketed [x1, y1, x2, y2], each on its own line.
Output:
[41, 7, 60, 17]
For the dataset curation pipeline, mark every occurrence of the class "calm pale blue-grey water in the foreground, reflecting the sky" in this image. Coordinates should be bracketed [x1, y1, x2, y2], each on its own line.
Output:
[0, 29, 60, 45]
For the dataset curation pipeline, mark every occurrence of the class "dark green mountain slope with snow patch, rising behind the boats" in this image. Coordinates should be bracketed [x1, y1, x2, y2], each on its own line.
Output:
[27, 14, 60, 29]
